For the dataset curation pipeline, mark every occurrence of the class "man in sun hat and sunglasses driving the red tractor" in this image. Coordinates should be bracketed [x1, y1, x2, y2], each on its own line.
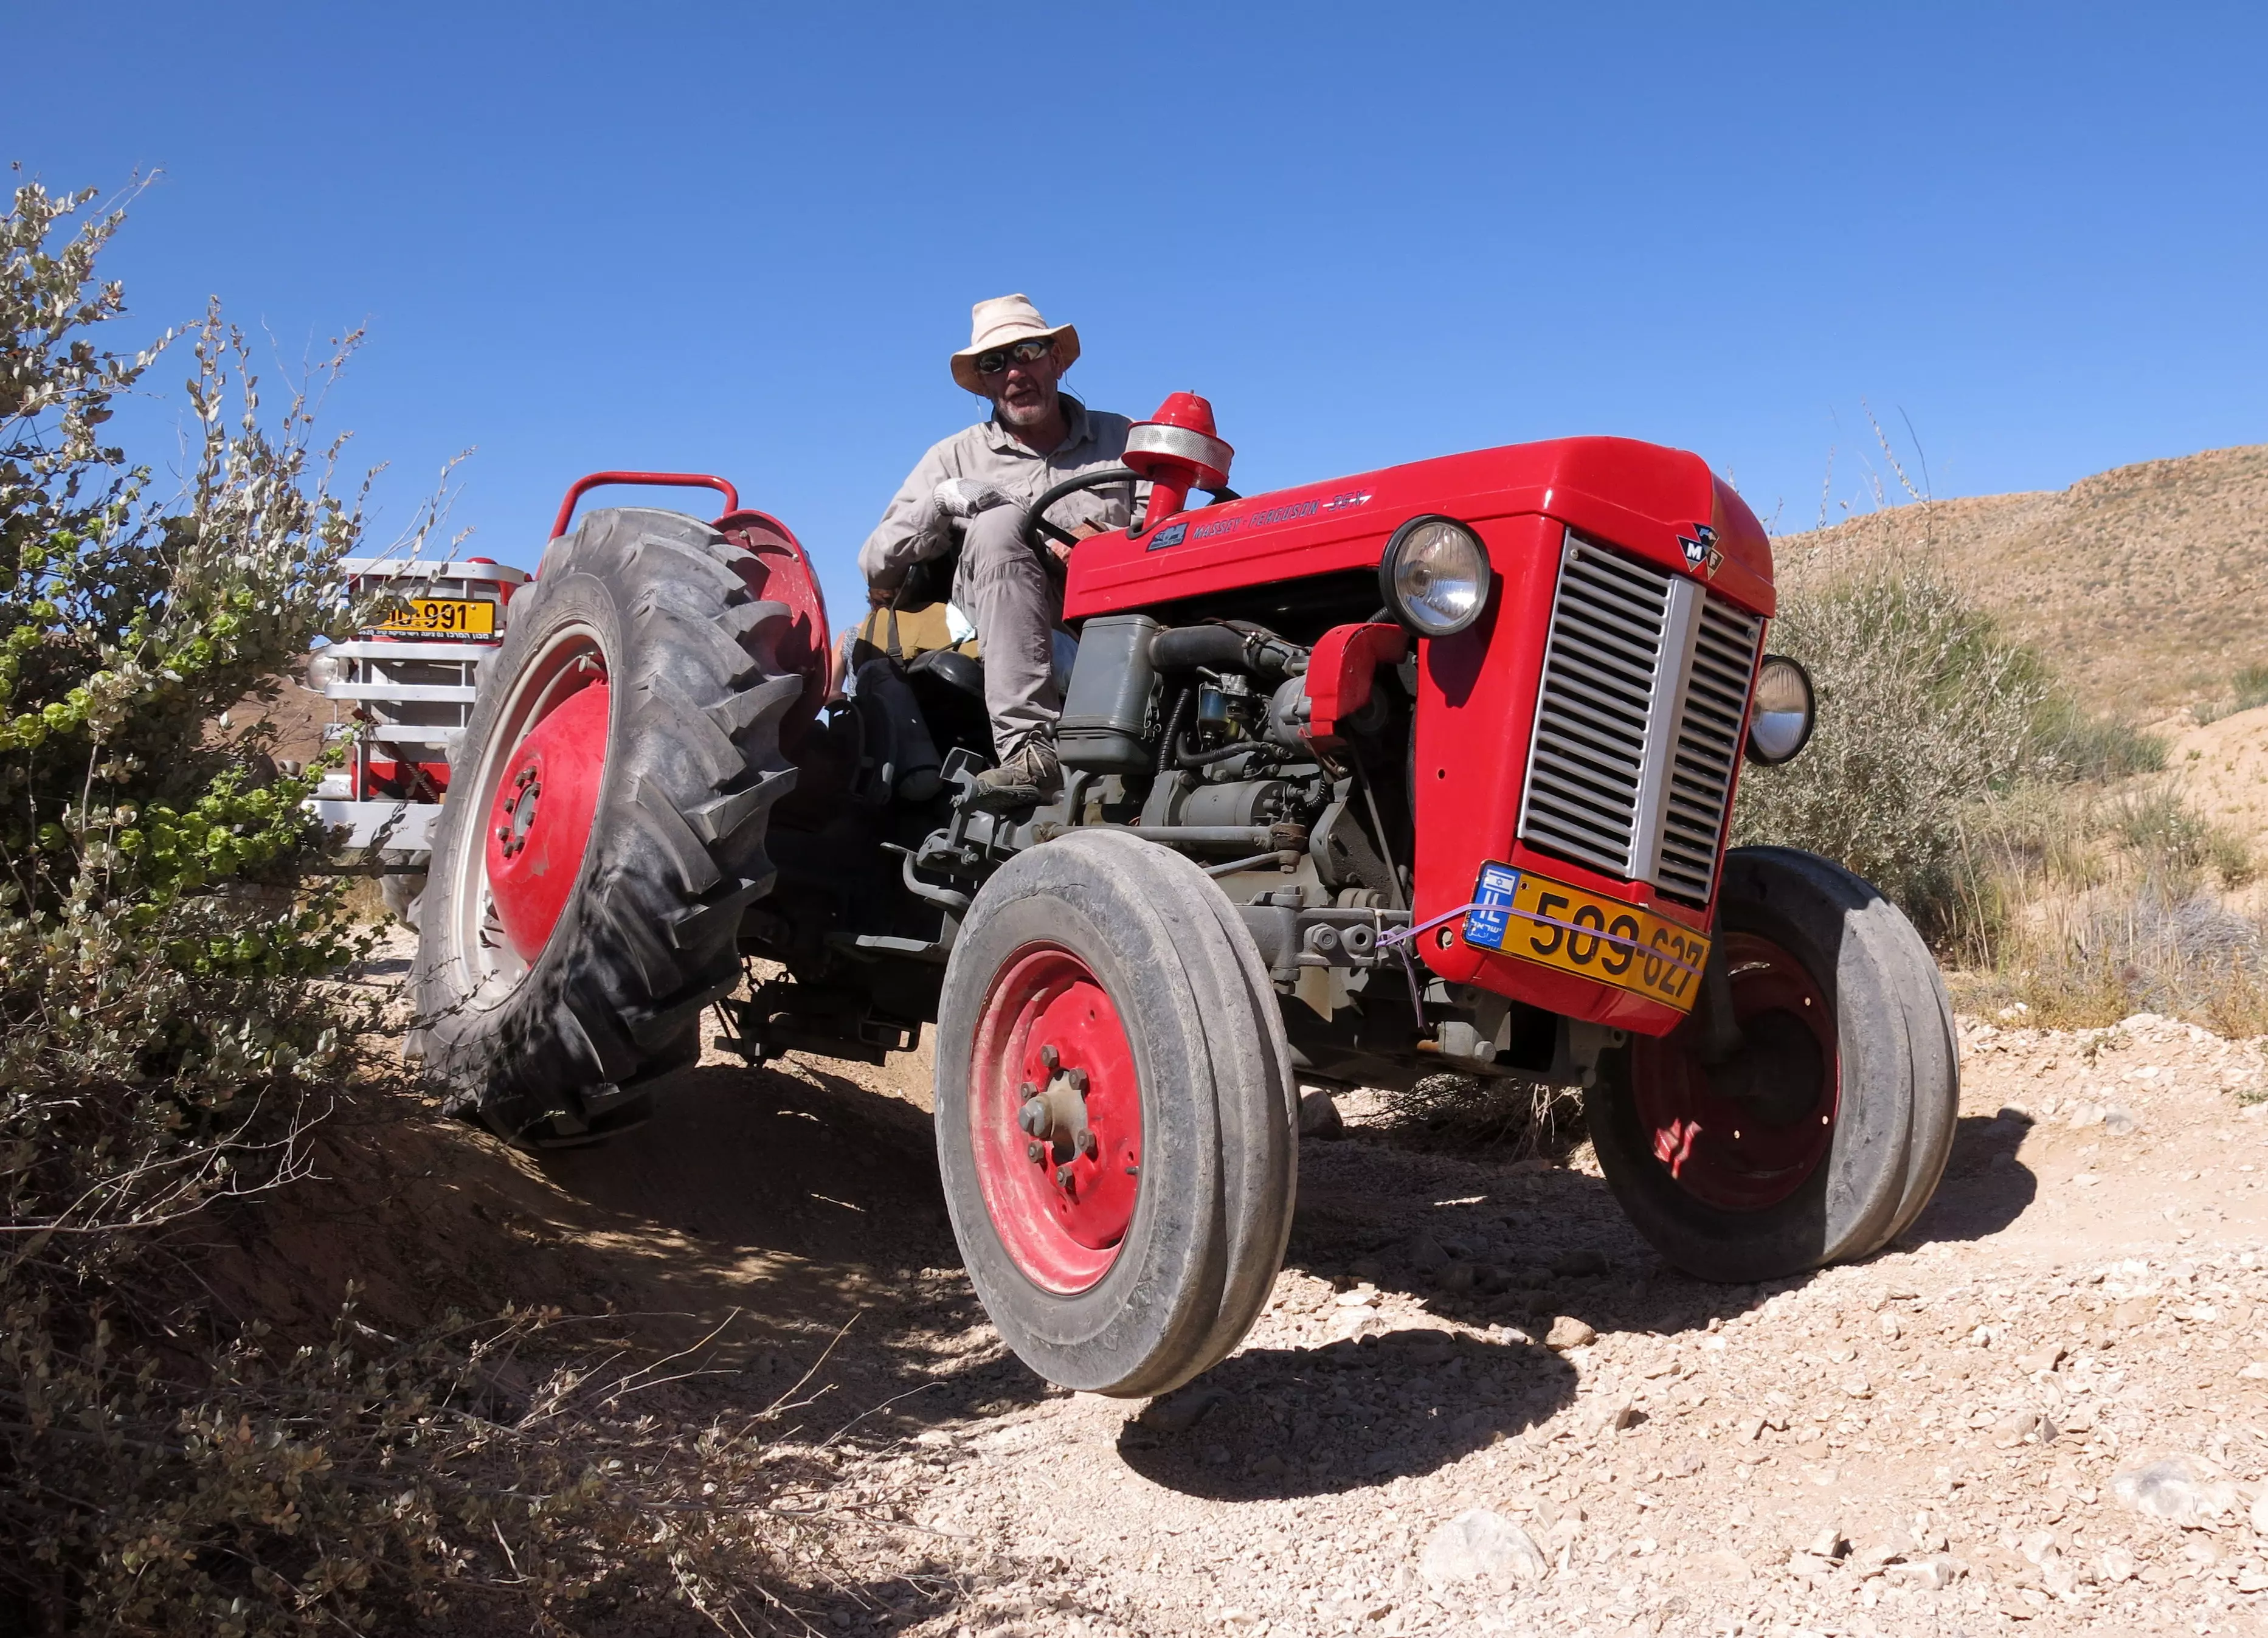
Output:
[857, 295, 1147, 807]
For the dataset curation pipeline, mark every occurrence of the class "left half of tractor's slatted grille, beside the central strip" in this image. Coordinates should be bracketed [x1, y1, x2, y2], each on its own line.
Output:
[1519, 536, 1676, 876]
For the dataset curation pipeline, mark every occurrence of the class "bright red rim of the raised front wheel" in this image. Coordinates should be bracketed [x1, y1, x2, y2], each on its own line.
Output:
[969, 944, 1143, 1296]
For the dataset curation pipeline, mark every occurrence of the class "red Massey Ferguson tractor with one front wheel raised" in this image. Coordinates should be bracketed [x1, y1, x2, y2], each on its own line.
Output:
[413, 395, 1957, 1395]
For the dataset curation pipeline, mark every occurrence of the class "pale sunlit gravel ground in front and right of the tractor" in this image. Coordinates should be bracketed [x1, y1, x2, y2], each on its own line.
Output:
[837, 1017, 2268, 1636]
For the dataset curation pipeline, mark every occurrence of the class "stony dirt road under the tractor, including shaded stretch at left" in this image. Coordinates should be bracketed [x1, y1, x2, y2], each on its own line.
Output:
[295, 953, 2268, 1636]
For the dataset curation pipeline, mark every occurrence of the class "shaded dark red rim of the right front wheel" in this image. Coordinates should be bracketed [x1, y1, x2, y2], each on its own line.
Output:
[1631, 933, 1842, 1212]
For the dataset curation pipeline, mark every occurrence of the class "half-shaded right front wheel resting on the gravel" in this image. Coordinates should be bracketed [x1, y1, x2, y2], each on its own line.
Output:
[1583, 849, 1960, 1282]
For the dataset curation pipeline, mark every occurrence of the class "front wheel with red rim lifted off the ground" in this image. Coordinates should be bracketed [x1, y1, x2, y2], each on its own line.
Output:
[936, 831, 1298, 1397]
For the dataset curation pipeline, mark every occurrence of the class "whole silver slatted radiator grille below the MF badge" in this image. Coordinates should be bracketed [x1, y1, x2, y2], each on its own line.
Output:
[1519, 533, 1762, 903]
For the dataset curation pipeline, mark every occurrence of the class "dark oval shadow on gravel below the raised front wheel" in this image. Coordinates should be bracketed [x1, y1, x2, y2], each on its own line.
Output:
[1118, 1330, 1576, 1502]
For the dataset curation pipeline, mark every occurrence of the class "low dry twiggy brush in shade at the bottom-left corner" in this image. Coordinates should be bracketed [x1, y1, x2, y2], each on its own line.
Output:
[0, 1279, 893, 1634]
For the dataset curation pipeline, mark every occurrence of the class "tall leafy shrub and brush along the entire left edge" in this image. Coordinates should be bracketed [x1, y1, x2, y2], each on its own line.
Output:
[0, 186, 875, 1636]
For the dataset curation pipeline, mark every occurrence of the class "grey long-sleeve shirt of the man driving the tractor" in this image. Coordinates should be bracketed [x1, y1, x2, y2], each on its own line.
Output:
[857, 393, 1147, 592]
